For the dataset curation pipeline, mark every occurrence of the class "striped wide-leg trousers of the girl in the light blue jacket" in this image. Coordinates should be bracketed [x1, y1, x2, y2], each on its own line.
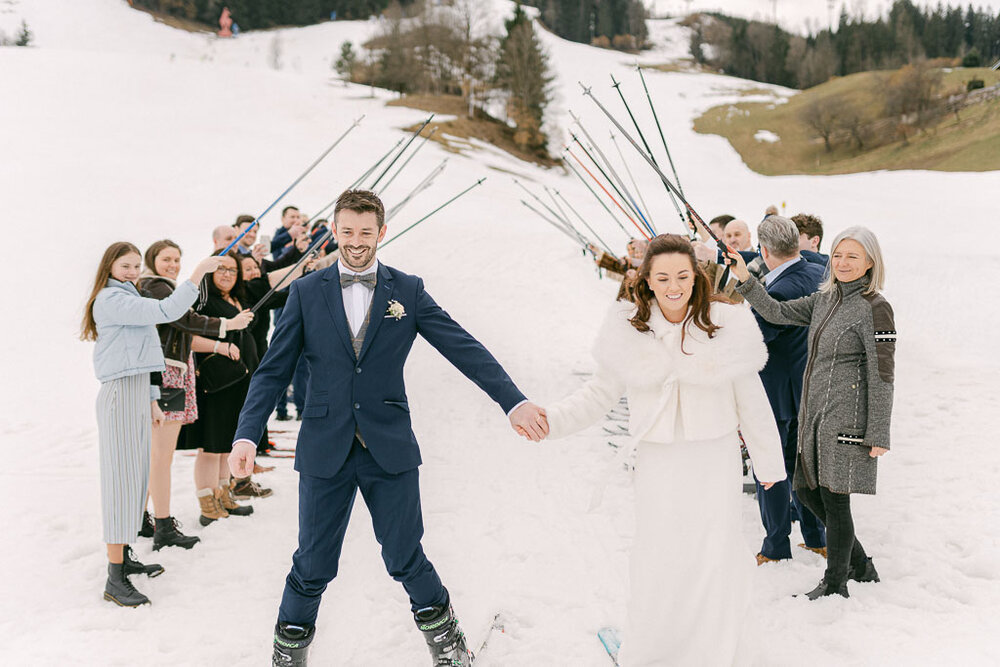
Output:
[97, 373, 153, 544]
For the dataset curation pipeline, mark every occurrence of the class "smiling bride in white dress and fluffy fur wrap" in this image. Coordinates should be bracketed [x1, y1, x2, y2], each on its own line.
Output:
[546, 234, 785, 667]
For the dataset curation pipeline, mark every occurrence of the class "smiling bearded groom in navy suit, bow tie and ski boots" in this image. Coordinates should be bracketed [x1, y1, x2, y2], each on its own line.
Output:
[229, 190, 548, 666]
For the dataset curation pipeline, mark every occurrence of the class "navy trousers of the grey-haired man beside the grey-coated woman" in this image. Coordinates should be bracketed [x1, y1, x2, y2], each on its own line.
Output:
[754, 419, 826, 560]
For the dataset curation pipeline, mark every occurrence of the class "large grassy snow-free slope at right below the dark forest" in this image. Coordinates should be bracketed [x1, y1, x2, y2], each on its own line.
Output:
[694, 68, 1000, 176]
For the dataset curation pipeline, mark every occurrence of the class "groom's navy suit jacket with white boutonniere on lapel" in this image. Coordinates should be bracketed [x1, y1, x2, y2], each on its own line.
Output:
[234, 264, 524, 478]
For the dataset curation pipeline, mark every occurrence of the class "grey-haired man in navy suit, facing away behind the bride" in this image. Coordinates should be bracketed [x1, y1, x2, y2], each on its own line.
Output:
[754, 215, 826, 565]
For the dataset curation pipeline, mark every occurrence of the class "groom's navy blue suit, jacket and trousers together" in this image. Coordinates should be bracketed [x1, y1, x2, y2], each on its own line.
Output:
[235, 264, 524, 624]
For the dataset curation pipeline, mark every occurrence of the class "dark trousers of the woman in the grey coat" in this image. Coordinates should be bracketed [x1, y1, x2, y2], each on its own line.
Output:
[798, 486, 868, 586]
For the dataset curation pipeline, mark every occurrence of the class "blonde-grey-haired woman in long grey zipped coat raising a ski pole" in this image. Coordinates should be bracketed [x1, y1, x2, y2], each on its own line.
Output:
[729, 226, 896, 600]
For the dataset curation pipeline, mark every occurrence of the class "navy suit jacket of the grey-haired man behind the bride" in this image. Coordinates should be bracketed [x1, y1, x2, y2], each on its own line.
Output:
[754, 260, 824, 421]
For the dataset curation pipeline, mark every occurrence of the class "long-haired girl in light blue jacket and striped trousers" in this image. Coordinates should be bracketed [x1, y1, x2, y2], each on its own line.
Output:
[80, 242, 220, 607]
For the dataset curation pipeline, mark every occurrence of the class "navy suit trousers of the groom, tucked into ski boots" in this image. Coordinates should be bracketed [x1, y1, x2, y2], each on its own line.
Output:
[278, 440, 448, 625]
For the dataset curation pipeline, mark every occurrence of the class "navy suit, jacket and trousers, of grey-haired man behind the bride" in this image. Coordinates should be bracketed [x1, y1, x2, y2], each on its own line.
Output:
[754, 260, 826, 560]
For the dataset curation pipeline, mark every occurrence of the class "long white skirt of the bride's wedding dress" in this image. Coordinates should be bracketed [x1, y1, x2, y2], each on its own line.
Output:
[621, 431, 755, 667]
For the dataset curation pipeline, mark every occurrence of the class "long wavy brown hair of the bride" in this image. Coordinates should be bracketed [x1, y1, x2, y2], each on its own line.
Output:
[627, 234, 726, 350]
